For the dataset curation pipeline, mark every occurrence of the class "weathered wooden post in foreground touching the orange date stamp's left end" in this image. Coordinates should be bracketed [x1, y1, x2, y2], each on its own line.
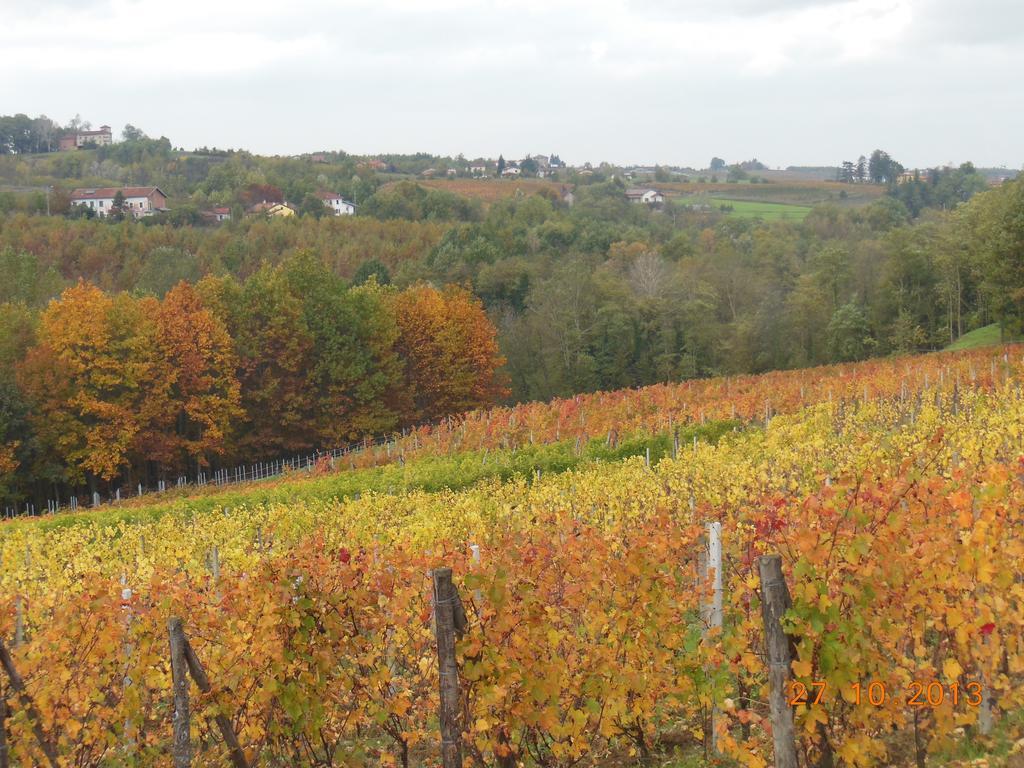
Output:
[758, 555, 797, 768]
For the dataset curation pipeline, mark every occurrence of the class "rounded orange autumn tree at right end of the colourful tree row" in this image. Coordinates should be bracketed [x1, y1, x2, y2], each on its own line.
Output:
[392, 285, 507, 422]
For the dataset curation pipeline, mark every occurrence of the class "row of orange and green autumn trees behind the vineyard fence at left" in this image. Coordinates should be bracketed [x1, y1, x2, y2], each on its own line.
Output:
[0, 251, 507, 499]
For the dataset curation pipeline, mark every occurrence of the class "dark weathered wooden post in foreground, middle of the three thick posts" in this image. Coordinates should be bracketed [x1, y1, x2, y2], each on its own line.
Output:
[431, 568, 466, 768]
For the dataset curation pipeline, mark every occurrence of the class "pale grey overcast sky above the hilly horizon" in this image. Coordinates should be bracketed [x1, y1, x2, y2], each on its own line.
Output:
[0, 0, 1024, 168]
